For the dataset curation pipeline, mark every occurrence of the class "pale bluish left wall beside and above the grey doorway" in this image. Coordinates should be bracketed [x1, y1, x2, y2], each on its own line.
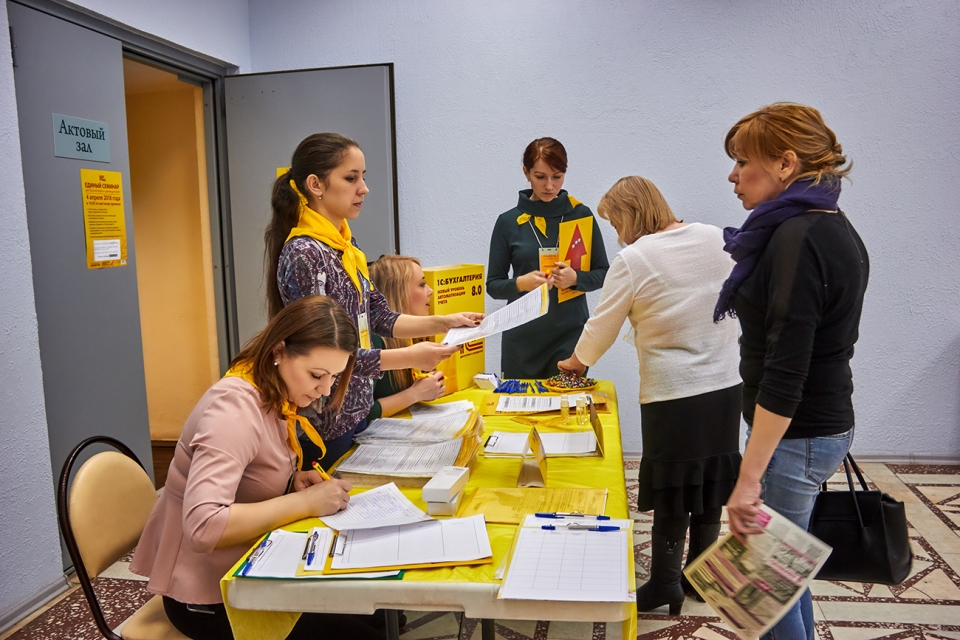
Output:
[0, 0, 250, 629]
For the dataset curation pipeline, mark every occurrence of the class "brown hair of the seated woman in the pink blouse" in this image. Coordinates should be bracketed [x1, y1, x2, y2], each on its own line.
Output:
[230, 296, 360, 415]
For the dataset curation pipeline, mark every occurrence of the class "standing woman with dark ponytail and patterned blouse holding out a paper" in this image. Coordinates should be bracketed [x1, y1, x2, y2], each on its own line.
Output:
[264, 133, 483, 468]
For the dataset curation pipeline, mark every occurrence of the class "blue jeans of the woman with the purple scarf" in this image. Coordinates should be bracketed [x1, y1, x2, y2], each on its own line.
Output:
[747, 428, 853, 640]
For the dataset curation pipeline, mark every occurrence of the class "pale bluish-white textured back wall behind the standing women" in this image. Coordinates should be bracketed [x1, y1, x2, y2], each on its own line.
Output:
[250, 0, 960, 458]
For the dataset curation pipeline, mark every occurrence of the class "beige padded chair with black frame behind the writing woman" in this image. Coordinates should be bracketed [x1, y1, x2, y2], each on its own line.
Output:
[57, 436, 189, 640]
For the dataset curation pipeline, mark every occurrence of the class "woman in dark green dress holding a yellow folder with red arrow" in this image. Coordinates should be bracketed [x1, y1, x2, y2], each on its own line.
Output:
[487, 138, 610, 378]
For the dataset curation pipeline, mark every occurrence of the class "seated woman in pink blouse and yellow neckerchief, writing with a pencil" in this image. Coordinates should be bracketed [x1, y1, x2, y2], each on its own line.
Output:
[130, 296, 383, 640]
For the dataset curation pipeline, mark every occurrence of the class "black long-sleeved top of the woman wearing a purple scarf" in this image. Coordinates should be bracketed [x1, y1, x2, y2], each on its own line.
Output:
[735, 212, 870, 439]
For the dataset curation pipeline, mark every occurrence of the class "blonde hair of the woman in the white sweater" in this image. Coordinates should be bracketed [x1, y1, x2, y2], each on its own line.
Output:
[597, 176, 677, 244]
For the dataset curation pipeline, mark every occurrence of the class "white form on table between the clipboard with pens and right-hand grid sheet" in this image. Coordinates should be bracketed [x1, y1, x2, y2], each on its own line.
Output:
[331, 515, 493, 569]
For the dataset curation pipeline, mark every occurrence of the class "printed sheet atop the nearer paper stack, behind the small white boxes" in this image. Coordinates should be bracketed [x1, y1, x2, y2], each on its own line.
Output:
[337, 438, 463, 476]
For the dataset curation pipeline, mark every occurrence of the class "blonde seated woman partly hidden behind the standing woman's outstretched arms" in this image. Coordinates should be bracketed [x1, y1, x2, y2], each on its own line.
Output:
[367, 255, 445, 422]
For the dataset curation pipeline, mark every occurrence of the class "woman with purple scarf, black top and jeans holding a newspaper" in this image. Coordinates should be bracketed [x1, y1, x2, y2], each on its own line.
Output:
[714, 103, 870, 640]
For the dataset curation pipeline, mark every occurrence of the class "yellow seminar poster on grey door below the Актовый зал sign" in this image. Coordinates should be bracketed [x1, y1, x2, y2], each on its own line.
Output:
[80, 169, 127, 269]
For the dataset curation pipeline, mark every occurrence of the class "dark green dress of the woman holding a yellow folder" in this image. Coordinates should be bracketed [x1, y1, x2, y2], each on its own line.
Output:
[487, 189, 610, 378]
